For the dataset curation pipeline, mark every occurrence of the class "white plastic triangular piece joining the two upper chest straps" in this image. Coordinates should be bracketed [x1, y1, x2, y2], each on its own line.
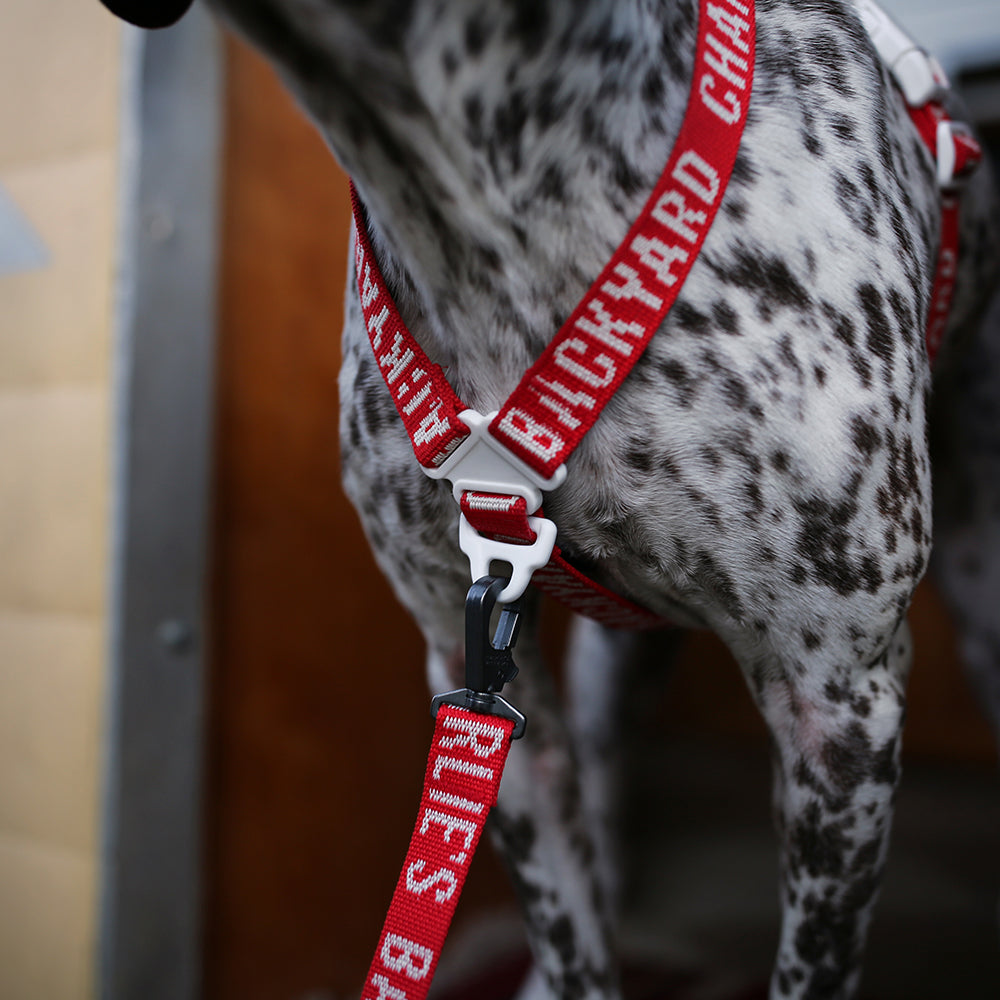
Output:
[423, 410, 566, 514]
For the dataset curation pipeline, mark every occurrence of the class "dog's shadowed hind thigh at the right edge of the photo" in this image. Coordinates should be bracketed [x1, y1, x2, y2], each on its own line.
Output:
[931, 297, 1000, 741]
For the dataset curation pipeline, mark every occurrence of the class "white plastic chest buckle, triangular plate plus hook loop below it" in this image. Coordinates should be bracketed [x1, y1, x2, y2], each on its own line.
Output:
[424, 410, 566, 604]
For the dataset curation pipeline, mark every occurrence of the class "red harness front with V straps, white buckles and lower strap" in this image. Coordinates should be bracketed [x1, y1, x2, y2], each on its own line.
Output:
[352, 0, 755, 628]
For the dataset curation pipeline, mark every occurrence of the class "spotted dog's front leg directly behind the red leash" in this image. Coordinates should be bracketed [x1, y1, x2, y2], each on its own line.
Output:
[430, 615, 620, 1000]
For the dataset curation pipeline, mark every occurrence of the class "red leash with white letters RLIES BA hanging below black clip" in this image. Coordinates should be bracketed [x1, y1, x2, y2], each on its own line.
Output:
[361, 705, 514, 1000]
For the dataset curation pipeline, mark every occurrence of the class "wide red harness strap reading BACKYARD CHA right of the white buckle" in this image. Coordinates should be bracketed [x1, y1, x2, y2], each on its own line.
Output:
[490, 0, 755, 476]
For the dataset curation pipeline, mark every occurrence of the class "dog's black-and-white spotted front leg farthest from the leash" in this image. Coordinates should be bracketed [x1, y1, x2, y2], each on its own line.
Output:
[747, 622, 911, 1000]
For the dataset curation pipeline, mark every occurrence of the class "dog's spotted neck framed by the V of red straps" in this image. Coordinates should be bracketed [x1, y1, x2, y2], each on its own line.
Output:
[214, 0, 696, 405]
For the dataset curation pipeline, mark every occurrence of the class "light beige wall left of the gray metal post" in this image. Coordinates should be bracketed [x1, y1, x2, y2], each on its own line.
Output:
[0, 0, 120, 1000]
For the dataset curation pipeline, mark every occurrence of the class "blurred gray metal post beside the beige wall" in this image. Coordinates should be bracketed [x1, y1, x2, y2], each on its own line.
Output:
[97, 5, 222, 1000]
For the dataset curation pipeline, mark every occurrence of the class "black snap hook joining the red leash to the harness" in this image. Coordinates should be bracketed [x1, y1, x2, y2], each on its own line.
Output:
[431, 576, 527, 740]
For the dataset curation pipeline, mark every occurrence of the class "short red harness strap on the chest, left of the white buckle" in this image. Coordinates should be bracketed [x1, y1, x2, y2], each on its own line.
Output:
[351, 183, 469, 468]
